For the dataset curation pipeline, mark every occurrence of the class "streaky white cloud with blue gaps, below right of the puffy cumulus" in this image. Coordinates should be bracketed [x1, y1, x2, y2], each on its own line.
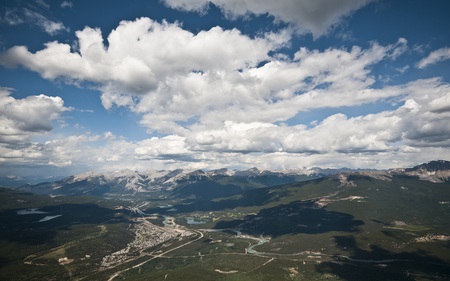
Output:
[134, 37, 403, 134]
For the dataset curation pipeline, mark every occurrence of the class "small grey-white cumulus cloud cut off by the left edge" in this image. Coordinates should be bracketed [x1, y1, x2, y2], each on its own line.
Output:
[0, 88, 70, 143]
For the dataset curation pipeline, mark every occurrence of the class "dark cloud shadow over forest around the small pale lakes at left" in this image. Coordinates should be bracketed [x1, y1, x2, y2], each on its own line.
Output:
[0, 204, 130, 245]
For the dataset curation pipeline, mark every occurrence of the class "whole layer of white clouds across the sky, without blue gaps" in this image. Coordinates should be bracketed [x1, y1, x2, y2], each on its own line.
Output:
[0, 17, 450, 173]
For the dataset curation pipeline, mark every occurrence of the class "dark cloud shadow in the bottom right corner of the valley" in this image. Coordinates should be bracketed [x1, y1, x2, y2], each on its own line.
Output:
[317, 236, 450, 281]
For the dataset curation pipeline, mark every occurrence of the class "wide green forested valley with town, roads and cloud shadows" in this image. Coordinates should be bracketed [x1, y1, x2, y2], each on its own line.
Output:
[0, 161, 450, 280]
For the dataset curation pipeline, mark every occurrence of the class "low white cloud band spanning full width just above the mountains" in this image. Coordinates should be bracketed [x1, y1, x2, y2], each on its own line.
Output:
[0, 75, 450, 171]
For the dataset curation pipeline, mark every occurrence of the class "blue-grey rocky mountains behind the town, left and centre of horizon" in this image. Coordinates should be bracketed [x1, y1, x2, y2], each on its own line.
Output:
[15, 168, 324, 198]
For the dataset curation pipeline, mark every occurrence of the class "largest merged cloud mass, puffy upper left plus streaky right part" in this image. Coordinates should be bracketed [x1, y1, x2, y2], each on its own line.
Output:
[0, 18, 407, 135]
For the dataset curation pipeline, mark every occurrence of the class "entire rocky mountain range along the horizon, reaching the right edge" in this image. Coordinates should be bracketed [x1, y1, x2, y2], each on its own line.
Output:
[11, 160, 450, 199]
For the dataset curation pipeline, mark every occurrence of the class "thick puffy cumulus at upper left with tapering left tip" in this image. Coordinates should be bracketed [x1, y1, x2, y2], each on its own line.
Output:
[1, 18, 282, 108]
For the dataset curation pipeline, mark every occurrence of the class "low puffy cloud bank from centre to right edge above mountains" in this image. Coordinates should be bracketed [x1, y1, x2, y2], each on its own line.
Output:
[187, 79, 450, 154]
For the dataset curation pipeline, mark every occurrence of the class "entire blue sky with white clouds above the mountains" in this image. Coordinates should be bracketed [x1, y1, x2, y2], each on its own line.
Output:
[0, 0, 450, 176]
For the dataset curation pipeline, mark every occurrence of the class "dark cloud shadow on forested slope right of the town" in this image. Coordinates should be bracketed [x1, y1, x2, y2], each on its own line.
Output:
[214, 200, 364, 236]
